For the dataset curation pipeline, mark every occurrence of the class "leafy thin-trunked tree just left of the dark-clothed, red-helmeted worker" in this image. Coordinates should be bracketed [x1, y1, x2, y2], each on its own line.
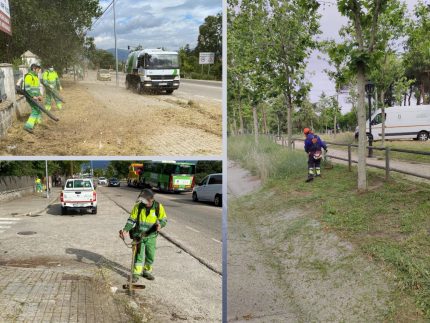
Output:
[265, 0, 320, 149]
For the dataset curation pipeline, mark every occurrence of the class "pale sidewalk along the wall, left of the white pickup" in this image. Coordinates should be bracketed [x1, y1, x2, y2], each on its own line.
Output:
[0, 187, 61, 217]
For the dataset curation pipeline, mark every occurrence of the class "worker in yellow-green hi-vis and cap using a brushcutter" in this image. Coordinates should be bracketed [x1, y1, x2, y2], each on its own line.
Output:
[120, 189, 167, 282]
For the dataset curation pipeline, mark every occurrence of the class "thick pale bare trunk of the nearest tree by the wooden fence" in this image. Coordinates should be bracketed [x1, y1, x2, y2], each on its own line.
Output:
[357, 64, 367, 192]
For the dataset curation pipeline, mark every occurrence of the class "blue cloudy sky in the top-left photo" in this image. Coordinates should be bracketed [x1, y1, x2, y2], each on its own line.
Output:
[88, 0, 222, 50]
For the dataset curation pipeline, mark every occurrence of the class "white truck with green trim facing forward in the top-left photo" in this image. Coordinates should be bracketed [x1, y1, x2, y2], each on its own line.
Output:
[125, 49, 180, 94]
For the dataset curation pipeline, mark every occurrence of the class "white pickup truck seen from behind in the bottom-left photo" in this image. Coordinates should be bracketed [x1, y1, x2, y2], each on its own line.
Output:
[60, 178, 97, 215]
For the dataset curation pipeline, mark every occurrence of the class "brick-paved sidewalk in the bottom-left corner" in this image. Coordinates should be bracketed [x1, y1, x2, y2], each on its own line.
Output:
[0, 266, 131, 323]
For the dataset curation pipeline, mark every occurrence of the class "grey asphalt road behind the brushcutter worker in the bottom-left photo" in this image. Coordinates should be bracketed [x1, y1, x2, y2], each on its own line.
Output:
[97, 185, 222, 272]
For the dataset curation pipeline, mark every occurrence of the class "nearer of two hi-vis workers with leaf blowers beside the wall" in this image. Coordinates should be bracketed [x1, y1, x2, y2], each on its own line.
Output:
[22, 64, 42, 133]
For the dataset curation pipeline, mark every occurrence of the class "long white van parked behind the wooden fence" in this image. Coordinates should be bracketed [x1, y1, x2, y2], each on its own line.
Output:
[355, 105, 430, 141]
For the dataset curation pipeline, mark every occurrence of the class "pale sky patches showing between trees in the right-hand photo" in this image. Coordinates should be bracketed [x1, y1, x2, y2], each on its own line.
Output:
[307, 0, 418, 113]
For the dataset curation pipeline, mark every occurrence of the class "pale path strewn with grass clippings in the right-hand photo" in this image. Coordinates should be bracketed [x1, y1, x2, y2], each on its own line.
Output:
[228, 163, 393, 322]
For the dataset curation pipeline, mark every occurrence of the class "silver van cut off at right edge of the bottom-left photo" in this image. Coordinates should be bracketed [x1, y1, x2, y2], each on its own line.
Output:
[193, 174, 222, 206]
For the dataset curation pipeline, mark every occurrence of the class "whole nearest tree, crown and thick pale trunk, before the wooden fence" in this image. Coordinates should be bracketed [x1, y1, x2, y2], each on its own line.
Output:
[337, 0, 404, 191]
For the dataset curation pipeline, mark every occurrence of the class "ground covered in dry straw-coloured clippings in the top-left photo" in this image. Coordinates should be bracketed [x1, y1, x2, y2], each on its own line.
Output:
[0, 79, 222, 156]
